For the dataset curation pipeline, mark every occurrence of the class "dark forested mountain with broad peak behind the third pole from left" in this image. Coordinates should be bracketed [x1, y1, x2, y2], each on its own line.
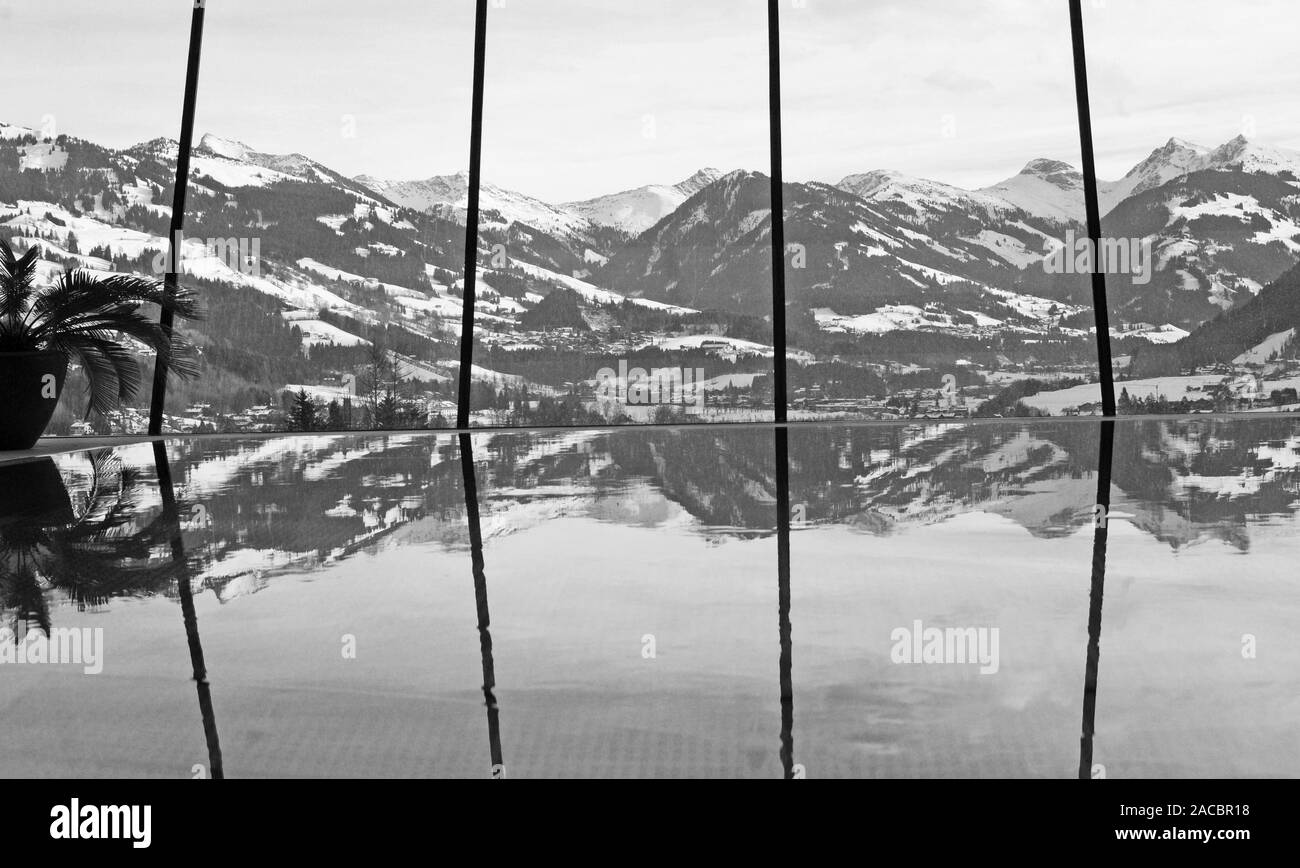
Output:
[594, 172, 1087, 337]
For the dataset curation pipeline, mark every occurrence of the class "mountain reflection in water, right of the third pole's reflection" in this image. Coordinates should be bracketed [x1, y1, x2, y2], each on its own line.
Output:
[790, 420, 1300, 551]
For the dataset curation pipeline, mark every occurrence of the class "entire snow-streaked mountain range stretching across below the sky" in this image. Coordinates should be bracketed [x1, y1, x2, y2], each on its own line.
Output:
[10, 118, 1300, 410]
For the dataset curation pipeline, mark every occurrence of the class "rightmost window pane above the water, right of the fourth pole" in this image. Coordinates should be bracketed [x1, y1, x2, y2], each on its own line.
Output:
[1084, 0, 1300, 413]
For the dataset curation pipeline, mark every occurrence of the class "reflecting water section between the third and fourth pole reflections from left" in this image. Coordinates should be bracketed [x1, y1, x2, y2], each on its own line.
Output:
[789, 422, 1097, 778]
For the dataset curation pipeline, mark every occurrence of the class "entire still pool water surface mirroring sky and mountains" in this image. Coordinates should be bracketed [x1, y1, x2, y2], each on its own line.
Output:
[0, 420, 1300, 777]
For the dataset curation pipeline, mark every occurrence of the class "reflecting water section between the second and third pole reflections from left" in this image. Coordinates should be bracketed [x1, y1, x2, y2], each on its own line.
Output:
[462, 428, 781, 778]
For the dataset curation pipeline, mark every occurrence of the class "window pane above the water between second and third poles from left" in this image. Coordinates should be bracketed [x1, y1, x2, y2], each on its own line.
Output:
[472, 0, 772, 425]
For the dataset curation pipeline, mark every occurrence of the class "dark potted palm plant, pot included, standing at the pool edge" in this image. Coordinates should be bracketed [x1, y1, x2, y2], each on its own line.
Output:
[0, 239, 199, 450]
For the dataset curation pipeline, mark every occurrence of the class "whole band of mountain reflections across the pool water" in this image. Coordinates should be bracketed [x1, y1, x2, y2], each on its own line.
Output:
[20, 420, 1300, 613]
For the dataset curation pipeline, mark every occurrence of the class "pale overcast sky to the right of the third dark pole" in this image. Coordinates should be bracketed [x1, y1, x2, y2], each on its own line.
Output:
[781, 0, 1300, 187]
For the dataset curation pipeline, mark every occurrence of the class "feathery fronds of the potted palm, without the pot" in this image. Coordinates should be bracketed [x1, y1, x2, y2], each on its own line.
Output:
[0, 240, 199, 413]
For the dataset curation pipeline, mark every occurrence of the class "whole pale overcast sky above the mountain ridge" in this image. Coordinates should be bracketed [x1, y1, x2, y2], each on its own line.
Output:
[0, 0, 1300, 201]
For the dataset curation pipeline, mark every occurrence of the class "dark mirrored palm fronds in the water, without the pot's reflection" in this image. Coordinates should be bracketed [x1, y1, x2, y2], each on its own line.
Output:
[0, 451, 185, 633]
